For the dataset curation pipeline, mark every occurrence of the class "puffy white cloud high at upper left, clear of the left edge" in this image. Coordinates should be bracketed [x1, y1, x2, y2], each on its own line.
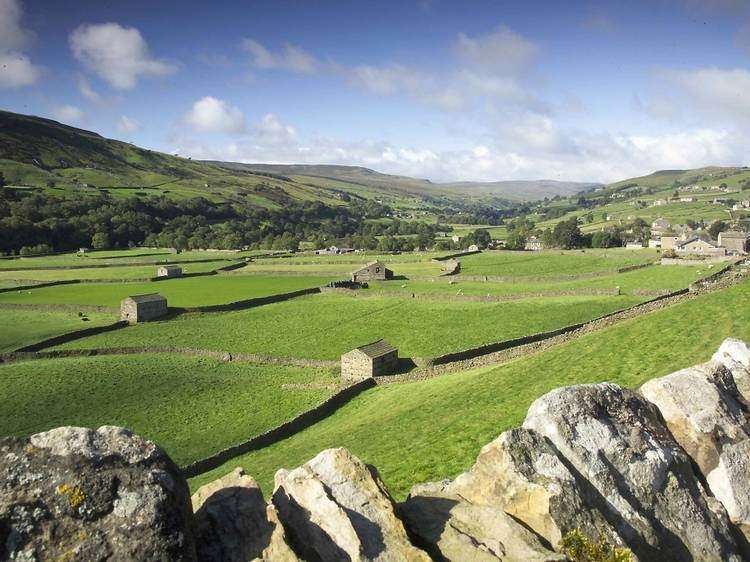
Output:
[68, 23, 177, 90]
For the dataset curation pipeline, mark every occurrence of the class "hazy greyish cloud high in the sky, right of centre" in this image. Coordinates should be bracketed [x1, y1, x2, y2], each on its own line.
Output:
[454, 25, 539, 75]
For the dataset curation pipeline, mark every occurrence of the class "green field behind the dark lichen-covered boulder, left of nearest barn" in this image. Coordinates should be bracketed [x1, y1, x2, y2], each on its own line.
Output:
[0, 354, 336, 464]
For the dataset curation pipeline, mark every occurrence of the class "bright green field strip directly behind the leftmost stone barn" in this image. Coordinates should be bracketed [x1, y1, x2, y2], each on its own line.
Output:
[0, 275, 331, 306]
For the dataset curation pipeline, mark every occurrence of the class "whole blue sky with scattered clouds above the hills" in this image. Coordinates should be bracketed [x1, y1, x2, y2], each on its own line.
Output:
[0, 0, 750, 182]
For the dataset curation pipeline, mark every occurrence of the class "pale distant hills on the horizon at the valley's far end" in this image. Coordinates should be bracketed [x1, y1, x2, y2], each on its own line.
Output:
[210, 161, 601, 201]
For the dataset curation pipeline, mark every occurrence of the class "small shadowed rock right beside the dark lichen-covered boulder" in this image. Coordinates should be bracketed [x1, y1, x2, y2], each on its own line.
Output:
[192, 468, 299, 562]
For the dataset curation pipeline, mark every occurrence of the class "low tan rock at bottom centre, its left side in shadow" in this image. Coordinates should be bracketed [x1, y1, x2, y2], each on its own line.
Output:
[400, 480, 565, 562]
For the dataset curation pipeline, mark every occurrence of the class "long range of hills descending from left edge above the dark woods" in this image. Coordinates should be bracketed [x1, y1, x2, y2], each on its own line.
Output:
[0, 111, 597, 209]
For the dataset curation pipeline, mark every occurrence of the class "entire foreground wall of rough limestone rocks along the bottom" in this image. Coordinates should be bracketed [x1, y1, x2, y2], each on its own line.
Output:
[0, 339, 750, 562]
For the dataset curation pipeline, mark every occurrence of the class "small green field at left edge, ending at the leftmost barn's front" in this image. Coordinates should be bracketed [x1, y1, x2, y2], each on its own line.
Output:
[0, 309, 118, 353]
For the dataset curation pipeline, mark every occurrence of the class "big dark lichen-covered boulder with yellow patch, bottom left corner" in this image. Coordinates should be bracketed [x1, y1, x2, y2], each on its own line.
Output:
[0, 426, 196, 562]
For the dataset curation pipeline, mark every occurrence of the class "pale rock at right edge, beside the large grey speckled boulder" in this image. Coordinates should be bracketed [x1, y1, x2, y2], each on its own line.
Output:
[640, 361, 750, 534]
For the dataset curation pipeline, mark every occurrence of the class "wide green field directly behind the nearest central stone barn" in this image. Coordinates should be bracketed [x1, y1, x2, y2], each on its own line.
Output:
[57, 294, 640, 359]
